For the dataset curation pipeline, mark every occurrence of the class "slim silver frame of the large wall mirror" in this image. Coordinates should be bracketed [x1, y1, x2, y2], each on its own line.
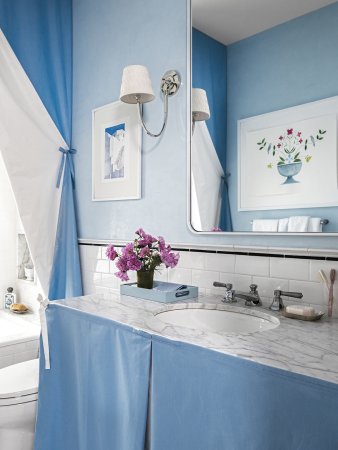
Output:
[186, 0, 338, 238]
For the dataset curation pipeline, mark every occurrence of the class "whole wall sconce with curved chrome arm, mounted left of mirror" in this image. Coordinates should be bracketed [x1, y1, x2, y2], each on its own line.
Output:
[120, 65, 181, 137]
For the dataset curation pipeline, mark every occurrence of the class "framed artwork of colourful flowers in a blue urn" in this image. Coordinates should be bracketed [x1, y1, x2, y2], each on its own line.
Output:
[238, 97, 338, 211]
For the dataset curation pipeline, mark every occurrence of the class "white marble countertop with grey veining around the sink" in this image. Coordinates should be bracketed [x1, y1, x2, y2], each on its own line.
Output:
[55, 293, 338, 383]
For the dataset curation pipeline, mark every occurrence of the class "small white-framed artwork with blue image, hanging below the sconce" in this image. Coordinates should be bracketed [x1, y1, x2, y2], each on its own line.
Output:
[92, 101, 142, 201]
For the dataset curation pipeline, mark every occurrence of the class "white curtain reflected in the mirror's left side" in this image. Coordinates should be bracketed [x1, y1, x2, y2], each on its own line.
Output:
[191, 122, 224, 231]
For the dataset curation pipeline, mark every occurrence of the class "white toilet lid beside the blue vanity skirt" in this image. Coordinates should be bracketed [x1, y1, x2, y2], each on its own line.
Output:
[0, 359, 39, 399]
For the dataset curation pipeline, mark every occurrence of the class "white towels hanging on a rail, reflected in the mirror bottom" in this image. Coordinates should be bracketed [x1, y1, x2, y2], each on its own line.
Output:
[252, 216, 323, 233]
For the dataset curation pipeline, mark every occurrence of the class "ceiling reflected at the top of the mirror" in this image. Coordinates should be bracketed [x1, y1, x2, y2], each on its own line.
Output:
[191, 0, 336, 45]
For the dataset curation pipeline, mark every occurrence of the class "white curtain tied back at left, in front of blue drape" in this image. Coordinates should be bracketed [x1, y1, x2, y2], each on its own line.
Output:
[0, 30, 66, 295]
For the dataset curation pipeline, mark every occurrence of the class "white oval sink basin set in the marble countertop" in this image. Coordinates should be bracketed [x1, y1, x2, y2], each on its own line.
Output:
[156, 305, 280, 334]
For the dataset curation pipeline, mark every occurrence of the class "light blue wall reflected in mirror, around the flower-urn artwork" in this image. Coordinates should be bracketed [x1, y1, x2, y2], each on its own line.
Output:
[227, 3, 338, 232]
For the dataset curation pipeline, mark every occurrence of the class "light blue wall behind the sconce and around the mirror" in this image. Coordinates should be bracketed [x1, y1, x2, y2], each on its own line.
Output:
[73, 0, 338, 248]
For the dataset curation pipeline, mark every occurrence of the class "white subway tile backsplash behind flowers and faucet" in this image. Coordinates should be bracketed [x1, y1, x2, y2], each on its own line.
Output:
[80, 245, 338, 318]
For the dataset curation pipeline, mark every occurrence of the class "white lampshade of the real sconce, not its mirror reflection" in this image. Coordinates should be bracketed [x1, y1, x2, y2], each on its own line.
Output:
[120, 65, 155, 104]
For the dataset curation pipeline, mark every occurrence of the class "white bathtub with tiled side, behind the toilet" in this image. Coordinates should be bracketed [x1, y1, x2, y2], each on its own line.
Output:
[0, 310, 40, 369]
